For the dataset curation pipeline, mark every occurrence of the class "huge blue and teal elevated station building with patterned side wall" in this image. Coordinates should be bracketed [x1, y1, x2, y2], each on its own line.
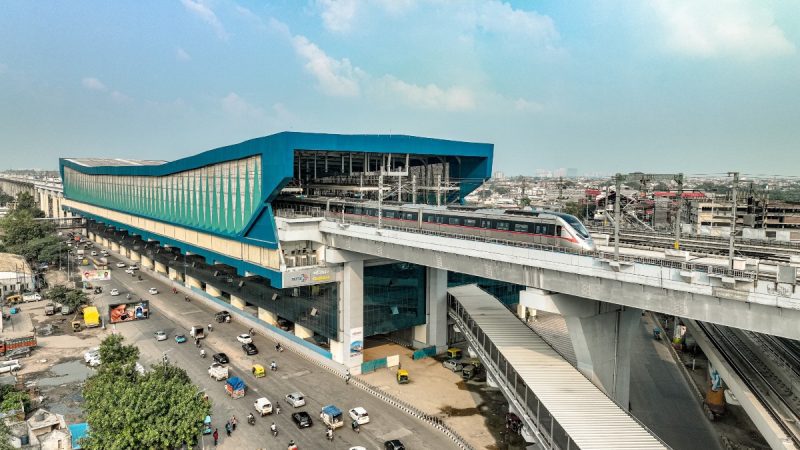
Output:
[60, 132, 494, 370]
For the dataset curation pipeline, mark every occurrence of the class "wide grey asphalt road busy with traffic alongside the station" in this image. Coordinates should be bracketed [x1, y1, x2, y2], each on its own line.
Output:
[87, 248, 456, 449]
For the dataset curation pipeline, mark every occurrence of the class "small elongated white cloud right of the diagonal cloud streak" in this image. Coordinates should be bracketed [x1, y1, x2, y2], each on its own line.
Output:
[376, 75, 475, 111]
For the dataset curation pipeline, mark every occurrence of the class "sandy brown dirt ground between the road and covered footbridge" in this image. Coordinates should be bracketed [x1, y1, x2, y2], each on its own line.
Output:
[360, 339, 525, 450]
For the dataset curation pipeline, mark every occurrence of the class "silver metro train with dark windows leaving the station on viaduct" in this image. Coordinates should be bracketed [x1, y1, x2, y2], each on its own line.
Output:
[275, 196, 595, 251]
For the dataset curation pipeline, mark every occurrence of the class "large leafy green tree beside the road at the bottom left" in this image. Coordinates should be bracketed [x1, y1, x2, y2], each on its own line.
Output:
[81, 336, 210, 450]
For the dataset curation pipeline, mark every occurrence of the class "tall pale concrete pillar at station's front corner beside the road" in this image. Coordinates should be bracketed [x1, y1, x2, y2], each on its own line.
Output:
[330, 260, 364, 375]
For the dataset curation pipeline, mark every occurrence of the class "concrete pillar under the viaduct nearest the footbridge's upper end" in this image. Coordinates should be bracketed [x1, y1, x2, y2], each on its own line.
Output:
[414, 267, 447, 353]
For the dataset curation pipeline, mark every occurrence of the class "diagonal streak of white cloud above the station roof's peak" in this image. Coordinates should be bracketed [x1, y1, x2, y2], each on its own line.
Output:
[292, 35, 363, 97]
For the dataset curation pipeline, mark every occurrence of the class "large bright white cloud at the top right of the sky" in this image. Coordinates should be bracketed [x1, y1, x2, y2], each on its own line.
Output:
[650, 0, 795, 59]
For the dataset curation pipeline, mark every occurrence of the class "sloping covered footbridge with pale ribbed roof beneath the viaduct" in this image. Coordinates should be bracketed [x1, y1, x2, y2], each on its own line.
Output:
[447, 284, 669, 449]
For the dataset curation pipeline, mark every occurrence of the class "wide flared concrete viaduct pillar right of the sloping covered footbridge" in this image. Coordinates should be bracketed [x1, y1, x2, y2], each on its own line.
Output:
[520, 288, 642, 410]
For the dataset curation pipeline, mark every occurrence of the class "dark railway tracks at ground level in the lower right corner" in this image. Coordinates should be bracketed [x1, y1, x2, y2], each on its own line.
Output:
[698, 322, 800, 448]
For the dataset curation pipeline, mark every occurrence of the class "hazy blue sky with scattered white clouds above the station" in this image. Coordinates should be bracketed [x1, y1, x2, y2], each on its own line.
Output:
[0, 0, 800, 175]
